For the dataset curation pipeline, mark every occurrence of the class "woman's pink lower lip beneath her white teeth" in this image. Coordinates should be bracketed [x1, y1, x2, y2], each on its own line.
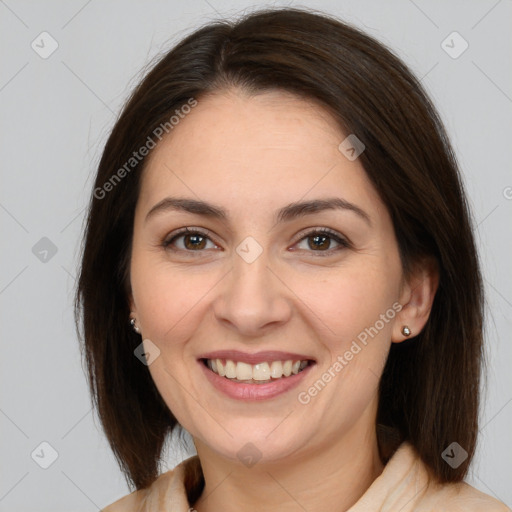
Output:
[199, 361, 313, 401]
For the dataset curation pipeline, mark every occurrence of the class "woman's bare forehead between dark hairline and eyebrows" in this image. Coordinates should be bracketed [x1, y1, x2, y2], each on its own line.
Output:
[139, 91, 379, 218]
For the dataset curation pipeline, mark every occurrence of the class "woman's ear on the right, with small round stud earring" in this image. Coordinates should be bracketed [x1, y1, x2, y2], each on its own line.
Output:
[391, 257, 439, 343]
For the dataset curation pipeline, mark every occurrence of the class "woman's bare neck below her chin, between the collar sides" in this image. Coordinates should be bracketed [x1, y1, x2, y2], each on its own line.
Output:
[194, 418, 383, 512]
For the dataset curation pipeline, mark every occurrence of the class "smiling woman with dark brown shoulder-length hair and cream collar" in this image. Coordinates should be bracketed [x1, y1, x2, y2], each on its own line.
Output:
[77, 9, 509, 512]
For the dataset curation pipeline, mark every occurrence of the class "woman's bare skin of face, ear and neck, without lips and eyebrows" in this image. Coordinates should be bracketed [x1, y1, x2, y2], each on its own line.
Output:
[130, 90, 437, 512]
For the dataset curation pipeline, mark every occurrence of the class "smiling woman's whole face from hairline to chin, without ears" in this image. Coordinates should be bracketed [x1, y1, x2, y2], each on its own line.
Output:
[130, 91, 403, 461]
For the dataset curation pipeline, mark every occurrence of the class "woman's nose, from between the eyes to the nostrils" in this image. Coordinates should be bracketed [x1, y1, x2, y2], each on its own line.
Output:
[213, 252, 292, 337]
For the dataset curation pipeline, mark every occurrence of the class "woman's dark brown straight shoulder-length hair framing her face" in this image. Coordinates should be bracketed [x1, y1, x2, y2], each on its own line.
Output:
[76, 9, 483, 489]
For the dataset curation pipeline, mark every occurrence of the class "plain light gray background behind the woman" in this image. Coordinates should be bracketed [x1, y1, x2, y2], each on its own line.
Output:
[0, 0, 512, 512]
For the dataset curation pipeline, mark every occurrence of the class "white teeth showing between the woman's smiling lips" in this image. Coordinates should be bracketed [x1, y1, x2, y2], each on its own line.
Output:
[202, 359, 314, 384]
